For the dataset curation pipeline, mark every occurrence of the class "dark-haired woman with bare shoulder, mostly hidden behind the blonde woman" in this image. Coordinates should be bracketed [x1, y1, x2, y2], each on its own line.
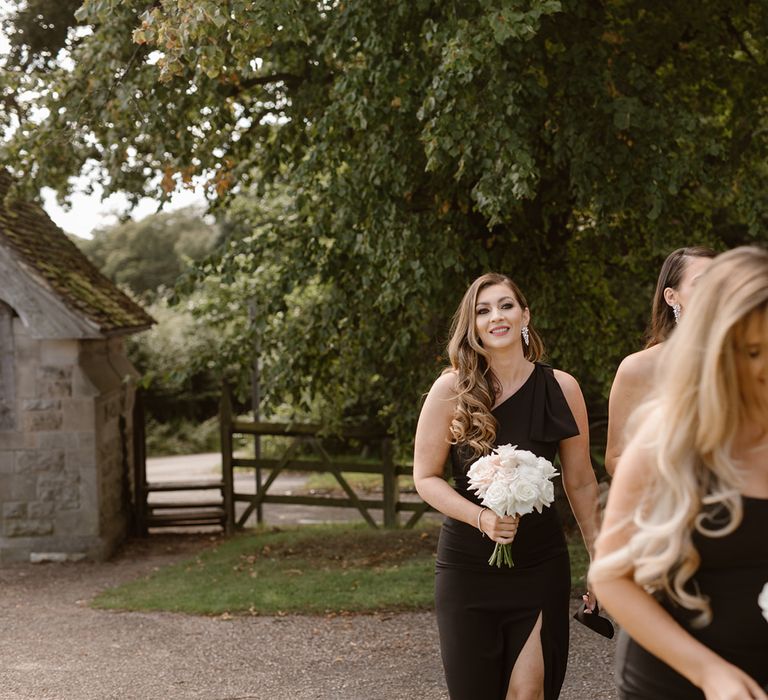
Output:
[605, 246, 715, 475]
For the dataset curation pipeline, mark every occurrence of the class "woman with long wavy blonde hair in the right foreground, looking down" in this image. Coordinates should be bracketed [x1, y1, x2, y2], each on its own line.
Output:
[590, 247, 768, 700]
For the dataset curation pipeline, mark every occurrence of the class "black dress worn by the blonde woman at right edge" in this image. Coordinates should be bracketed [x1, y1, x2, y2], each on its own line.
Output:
[616, 496, 768, 700]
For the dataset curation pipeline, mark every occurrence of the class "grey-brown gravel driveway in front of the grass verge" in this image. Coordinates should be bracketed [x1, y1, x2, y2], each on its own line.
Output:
[0, 534, 616, 700]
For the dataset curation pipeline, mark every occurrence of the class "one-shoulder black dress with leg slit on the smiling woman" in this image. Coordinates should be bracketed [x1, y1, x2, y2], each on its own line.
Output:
[435, 363, 579, 700]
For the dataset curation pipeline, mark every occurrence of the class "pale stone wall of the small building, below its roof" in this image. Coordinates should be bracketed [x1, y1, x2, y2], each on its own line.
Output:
[0, 318, 135, 562]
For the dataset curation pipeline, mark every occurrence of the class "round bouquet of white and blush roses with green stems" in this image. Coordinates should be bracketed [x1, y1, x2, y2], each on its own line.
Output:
[467, 445, 559, 567]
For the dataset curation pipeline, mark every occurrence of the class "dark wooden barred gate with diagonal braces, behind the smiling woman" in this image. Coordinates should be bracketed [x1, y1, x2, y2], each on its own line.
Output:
[220, 389, 430, 532]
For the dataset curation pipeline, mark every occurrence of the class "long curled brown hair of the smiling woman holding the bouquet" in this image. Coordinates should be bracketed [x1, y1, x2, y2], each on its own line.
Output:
[445, 272, 544, 456]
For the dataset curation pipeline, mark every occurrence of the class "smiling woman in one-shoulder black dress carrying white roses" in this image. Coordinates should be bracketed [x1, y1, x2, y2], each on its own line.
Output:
[413, 274, 598, 700]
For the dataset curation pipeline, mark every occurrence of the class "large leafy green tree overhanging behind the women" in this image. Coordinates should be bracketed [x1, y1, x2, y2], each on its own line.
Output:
[1, 0, 768, 446]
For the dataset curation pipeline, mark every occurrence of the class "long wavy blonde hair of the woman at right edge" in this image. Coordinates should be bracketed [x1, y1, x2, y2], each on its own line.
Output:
[590, 246, 768, 626]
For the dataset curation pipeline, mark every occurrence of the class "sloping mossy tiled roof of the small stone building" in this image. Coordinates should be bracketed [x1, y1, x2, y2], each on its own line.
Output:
[0, 168, 155, 335]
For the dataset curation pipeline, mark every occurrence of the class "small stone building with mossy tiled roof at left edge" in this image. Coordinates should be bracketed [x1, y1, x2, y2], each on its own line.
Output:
[0, 170, 153, 563]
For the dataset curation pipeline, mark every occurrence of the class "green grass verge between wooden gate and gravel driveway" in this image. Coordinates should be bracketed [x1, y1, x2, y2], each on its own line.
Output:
[93, 524, 586, 615]
